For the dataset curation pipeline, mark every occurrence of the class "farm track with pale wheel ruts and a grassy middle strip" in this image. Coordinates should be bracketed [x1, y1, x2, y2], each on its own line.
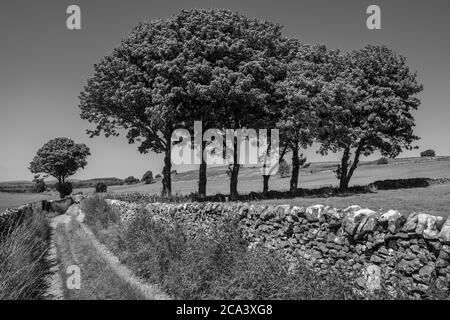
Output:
[51, 205, 170, 300]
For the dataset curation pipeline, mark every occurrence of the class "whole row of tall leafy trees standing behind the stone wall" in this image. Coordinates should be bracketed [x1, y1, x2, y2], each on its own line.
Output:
[76, 9, 422, 198]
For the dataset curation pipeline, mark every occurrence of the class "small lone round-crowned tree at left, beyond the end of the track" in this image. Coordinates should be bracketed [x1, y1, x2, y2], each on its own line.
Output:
[28, 138, 91, 198]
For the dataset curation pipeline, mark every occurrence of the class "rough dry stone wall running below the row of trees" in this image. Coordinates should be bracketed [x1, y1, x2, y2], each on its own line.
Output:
[106, 200, 450, 297]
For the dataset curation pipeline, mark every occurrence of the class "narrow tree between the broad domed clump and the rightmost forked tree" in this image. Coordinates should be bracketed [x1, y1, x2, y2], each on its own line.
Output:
[263, 39, 339, 192]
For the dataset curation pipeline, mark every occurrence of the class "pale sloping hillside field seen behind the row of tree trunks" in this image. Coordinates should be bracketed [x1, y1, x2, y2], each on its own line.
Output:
[76, 157, 450, 195]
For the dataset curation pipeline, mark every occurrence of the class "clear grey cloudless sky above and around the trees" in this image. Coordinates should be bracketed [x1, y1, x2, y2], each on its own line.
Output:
[0, 0, 450, 181]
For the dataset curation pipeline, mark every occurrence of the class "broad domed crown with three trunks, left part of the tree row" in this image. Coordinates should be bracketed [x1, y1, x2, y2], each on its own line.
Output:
[80, 9, 285, 198]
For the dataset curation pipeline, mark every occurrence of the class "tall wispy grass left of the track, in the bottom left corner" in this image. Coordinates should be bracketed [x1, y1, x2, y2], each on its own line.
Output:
[0, 212, 51, 300]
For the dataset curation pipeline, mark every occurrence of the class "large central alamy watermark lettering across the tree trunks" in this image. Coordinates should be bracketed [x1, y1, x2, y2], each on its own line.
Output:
[171, 121, 280, 175]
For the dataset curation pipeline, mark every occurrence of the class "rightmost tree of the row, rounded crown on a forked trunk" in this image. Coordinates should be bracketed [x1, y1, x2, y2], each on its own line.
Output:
[317, 45, 423, 191]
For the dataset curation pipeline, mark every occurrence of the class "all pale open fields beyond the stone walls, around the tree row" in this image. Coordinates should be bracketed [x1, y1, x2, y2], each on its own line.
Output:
[0, 157, 450, 216]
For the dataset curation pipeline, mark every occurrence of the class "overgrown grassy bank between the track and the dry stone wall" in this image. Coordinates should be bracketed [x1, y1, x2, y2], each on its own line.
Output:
[82, 197, 370, 300]
